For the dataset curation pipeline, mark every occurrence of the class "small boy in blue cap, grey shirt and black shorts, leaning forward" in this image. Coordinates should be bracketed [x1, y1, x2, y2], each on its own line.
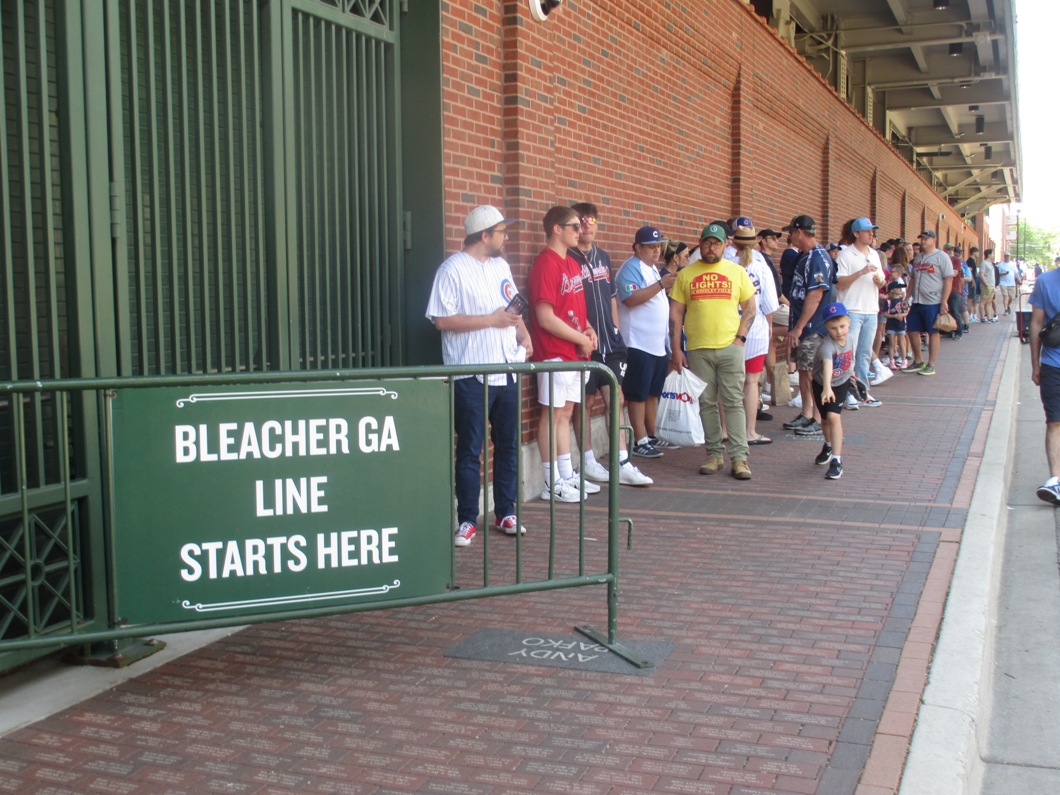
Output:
[812, 303, 854, 480]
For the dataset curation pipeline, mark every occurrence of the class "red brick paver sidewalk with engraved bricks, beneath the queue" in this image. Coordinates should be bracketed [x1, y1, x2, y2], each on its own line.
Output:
[0, 322, 1012, 795]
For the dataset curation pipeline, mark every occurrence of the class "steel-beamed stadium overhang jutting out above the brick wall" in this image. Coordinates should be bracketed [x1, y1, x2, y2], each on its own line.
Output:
[752, 0, 1023, 218]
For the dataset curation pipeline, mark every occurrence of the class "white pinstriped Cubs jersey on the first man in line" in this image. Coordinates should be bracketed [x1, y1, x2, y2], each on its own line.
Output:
[426, 251, 526, 386]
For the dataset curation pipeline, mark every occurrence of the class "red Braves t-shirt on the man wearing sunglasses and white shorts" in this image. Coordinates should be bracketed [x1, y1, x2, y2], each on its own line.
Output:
[530, 248, 588, 361]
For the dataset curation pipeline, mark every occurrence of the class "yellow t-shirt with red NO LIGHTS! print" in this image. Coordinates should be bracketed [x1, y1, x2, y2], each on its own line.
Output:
[670, 260, 755, 351]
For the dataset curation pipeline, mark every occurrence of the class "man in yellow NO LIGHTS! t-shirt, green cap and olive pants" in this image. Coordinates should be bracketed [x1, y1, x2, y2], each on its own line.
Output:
[670, 224, 755, 480]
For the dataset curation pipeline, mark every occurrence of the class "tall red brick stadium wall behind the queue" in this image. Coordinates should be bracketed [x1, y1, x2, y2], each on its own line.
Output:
[434, 0, 975, 432]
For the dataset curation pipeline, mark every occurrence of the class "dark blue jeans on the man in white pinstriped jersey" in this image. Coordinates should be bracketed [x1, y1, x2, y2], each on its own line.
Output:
[453, 375, 519, 523]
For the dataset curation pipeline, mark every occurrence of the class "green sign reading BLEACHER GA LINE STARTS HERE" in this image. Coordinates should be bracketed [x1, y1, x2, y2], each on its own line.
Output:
[110, 379, 453, 624]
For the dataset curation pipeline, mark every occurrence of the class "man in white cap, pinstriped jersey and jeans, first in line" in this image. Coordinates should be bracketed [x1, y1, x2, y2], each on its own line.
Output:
[426, 205, 533, 547]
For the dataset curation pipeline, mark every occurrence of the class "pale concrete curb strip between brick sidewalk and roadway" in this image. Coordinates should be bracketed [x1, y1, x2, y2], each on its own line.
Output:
[899, 337, 1021, 795]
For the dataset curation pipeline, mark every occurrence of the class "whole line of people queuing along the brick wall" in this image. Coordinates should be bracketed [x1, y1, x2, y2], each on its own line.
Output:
[426, 202, 996, 546]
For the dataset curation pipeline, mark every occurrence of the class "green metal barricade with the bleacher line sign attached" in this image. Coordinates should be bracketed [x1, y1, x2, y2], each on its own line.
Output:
[0, 363, 649, 667]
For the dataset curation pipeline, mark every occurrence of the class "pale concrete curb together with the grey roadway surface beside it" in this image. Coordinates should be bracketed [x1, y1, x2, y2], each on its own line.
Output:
[902, 330, 1060, 795]
